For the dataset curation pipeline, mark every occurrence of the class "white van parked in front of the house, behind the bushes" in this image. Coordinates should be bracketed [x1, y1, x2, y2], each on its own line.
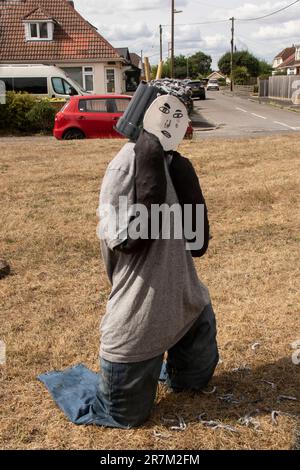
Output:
[0, 65, 89, 99]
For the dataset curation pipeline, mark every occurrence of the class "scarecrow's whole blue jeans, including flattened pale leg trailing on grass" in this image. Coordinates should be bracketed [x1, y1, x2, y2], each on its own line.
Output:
[38, 305, 219, 429]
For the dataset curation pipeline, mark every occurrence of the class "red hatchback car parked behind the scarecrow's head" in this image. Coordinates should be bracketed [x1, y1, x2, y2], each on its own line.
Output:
[53, 95, 131, 140]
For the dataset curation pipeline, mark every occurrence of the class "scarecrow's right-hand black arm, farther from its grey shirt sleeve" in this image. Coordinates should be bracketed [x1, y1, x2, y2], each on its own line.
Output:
[169, 152, 209, 258]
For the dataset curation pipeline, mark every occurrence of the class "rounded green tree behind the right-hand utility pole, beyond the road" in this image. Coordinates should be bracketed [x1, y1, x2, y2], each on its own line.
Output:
[218, 51, 260, 77]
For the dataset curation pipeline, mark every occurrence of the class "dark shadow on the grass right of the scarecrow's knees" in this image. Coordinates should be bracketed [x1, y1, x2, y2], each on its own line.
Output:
[146, 357, 300, 445]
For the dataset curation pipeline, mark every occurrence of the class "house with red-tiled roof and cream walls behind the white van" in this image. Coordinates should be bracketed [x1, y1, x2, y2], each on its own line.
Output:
[0, 0, 127, 94]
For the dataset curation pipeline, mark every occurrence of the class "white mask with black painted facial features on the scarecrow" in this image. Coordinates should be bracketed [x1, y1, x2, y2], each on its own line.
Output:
[144, 95, 189, 152]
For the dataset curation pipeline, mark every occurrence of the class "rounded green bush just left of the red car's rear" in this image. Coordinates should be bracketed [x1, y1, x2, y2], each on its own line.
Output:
[26, 99, 56, 132]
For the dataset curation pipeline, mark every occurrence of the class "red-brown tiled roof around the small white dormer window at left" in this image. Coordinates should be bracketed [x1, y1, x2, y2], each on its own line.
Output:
[0, 0, 120, 63]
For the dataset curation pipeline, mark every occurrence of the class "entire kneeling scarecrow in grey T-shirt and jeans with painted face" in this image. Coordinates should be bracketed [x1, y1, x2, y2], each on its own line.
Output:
[39, 81, 218, 428]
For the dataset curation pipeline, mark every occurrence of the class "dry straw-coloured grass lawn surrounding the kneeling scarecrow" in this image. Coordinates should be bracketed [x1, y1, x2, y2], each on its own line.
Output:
[0, 134, 300, 449]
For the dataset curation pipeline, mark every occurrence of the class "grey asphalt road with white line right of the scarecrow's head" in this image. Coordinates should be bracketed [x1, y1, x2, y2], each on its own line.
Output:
[193, 91, 300, 139]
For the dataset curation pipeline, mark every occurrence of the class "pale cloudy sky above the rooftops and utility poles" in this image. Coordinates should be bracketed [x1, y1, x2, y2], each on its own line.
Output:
[74, 0, 300, 70]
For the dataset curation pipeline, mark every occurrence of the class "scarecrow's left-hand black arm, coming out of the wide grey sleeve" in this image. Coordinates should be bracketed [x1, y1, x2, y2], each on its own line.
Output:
[116, 131, 167, 253]
